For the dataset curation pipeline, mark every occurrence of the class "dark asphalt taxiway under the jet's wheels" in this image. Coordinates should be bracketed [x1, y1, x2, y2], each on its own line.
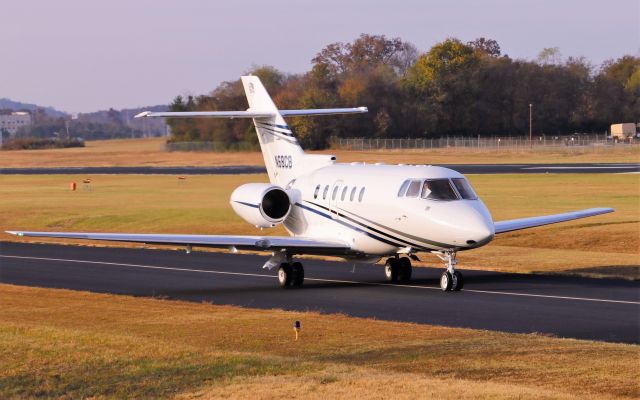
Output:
[0, 242, 640, 343]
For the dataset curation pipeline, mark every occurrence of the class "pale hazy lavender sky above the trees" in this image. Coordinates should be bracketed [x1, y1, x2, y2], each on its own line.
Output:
[0, 0, 640, 112]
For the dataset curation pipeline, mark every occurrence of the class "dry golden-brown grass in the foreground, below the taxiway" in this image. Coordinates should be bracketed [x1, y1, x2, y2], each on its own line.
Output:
[0, 285, 640, 399]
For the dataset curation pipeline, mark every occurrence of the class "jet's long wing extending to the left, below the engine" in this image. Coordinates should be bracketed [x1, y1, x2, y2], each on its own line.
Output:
[7, 231, 352, 255]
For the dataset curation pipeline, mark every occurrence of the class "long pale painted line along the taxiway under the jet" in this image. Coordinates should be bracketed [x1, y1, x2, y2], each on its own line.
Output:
[0, 255, 640, 305]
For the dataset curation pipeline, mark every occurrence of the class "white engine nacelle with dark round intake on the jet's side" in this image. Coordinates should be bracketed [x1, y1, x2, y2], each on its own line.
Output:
[230, 183, 291, 228]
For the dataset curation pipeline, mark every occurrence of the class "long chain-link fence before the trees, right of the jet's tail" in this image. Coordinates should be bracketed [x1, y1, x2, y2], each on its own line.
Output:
[331, 134, 638, 150]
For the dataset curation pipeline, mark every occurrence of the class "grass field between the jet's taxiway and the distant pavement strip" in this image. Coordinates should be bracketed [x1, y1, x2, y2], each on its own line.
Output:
[0, 174, 640, 279]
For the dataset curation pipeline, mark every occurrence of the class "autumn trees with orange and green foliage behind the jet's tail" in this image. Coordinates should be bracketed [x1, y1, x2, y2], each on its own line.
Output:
[168, 34, 640, 149]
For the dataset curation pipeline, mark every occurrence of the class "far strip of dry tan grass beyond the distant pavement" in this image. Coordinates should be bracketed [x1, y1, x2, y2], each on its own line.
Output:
[0, 138, 640, 168]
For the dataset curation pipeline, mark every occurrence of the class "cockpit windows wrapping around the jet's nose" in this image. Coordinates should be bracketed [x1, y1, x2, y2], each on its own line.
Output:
[398, 178, 478, 201]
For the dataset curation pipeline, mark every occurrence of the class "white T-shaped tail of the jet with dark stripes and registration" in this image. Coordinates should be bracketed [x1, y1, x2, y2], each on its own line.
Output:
[136, 76, 367, 186]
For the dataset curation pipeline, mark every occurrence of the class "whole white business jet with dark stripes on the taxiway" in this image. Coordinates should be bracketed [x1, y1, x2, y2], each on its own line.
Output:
[8, 76, 613, 291]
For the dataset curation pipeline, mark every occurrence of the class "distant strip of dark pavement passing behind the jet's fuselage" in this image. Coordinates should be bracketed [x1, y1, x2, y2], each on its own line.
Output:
[0, 163, 640, 175]
